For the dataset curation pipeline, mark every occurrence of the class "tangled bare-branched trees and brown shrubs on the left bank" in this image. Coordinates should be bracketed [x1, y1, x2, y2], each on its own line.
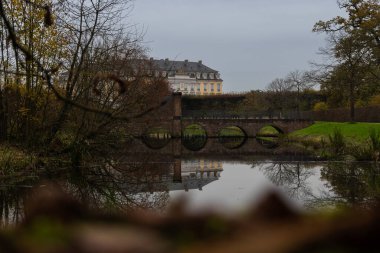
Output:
[0, 0, 167, 150]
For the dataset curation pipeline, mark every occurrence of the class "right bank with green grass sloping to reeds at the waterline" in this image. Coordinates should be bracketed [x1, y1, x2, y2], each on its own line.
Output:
[286, 122, 380, 161]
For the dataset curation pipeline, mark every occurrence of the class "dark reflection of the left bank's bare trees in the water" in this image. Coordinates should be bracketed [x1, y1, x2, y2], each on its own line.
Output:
[0, 159, 173, 226]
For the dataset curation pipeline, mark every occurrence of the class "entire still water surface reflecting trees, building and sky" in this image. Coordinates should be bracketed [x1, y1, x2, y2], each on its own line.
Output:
[0, 157, 380, 226]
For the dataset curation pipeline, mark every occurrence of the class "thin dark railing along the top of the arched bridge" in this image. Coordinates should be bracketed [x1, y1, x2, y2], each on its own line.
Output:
[182, 110, 314, 120]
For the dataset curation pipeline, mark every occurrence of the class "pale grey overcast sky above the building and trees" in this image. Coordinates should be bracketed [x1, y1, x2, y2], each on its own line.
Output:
[129, 0, 342, 91]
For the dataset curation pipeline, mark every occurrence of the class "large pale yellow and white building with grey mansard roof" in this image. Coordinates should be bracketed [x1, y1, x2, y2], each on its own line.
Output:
[150, 58, 223, 95]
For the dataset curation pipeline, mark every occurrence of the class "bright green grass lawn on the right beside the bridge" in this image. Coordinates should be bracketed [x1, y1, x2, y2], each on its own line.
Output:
[289, 122, 380, 142]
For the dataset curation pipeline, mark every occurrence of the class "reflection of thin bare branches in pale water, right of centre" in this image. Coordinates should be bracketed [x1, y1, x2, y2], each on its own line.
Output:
[259, 162, 314, 202]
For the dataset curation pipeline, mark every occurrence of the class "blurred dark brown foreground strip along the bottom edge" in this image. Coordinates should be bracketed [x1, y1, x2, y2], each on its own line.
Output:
[0, 186, 380, 253]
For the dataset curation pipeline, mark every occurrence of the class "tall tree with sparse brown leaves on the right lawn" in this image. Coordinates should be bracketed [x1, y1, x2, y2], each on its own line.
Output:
[313, 0, 380, 121]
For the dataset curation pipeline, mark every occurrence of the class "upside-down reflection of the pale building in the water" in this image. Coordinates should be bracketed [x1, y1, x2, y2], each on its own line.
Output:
[169, 160, 223, 191]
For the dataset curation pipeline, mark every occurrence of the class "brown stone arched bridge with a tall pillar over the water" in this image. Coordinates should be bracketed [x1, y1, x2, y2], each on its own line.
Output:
[127, 93, 313, 138]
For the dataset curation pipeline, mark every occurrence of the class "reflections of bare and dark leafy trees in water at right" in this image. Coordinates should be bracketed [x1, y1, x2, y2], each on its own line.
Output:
[259, 162, 380, 208]
